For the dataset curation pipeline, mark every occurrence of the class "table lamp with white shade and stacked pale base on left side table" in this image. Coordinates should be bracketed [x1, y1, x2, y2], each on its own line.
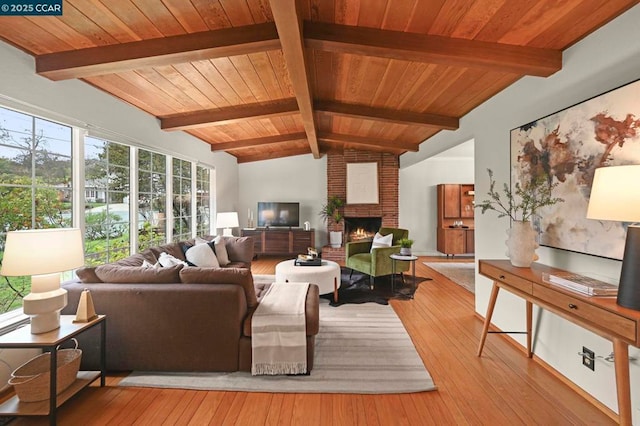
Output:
[0, 228, 84, 334]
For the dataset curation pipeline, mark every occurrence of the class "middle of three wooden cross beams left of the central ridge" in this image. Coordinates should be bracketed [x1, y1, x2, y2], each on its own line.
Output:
[160, 98, 298, 130]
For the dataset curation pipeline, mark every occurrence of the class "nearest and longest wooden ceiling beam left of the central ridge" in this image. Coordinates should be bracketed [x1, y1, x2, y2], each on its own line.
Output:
[36, 22, 280, 80]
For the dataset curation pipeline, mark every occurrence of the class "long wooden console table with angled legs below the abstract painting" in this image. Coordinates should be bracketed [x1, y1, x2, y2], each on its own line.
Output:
[478, 260, 640, 425]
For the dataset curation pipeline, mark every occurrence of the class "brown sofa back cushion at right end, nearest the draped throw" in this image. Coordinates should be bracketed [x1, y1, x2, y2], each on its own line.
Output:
[180, 266, 258, 308]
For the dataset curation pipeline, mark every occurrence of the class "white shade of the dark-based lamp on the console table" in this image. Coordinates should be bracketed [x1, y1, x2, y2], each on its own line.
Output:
[587, 165, 640, 222]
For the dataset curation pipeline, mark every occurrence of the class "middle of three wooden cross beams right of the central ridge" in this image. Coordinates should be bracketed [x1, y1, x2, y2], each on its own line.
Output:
[314, 100, 459, 130]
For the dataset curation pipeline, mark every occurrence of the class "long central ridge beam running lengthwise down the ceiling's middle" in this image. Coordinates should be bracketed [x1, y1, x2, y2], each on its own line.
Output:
[269, 0, 320, 158]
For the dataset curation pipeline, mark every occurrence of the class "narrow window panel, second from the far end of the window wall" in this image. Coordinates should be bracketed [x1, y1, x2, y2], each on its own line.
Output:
[173, 158, 192, 241]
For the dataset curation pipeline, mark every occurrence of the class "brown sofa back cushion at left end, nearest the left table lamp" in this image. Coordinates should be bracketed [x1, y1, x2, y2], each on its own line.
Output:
[96, 264, 183, 284]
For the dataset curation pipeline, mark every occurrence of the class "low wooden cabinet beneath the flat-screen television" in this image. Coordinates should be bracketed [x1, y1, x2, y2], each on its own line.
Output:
[241, 229, 316, 256]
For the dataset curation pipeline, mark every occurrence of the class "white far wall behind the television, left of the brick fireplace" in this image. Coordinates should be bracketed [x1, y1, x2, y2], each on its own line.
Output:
[238, 154, 328, 248]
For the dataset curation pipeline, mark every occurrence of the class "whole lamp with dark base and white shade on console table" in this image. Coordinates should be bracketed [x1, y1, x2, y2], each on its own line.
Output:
[587, 165, 640, 311]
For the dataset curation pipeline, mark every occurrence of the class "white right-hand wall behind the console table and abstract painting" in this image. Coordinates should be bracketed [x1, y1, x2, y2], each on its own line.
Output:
[401, 6, 640, 425]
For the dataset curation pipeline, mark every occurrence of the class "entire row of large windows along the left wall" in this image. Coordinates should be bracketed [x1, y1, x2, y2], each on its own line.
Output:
[0, 107, 213, 314]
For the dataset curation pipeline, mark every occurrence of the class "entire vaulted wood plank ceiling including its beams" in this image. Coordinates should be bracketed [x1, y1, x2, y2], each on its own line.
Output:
[0, 0, 638, 162]
